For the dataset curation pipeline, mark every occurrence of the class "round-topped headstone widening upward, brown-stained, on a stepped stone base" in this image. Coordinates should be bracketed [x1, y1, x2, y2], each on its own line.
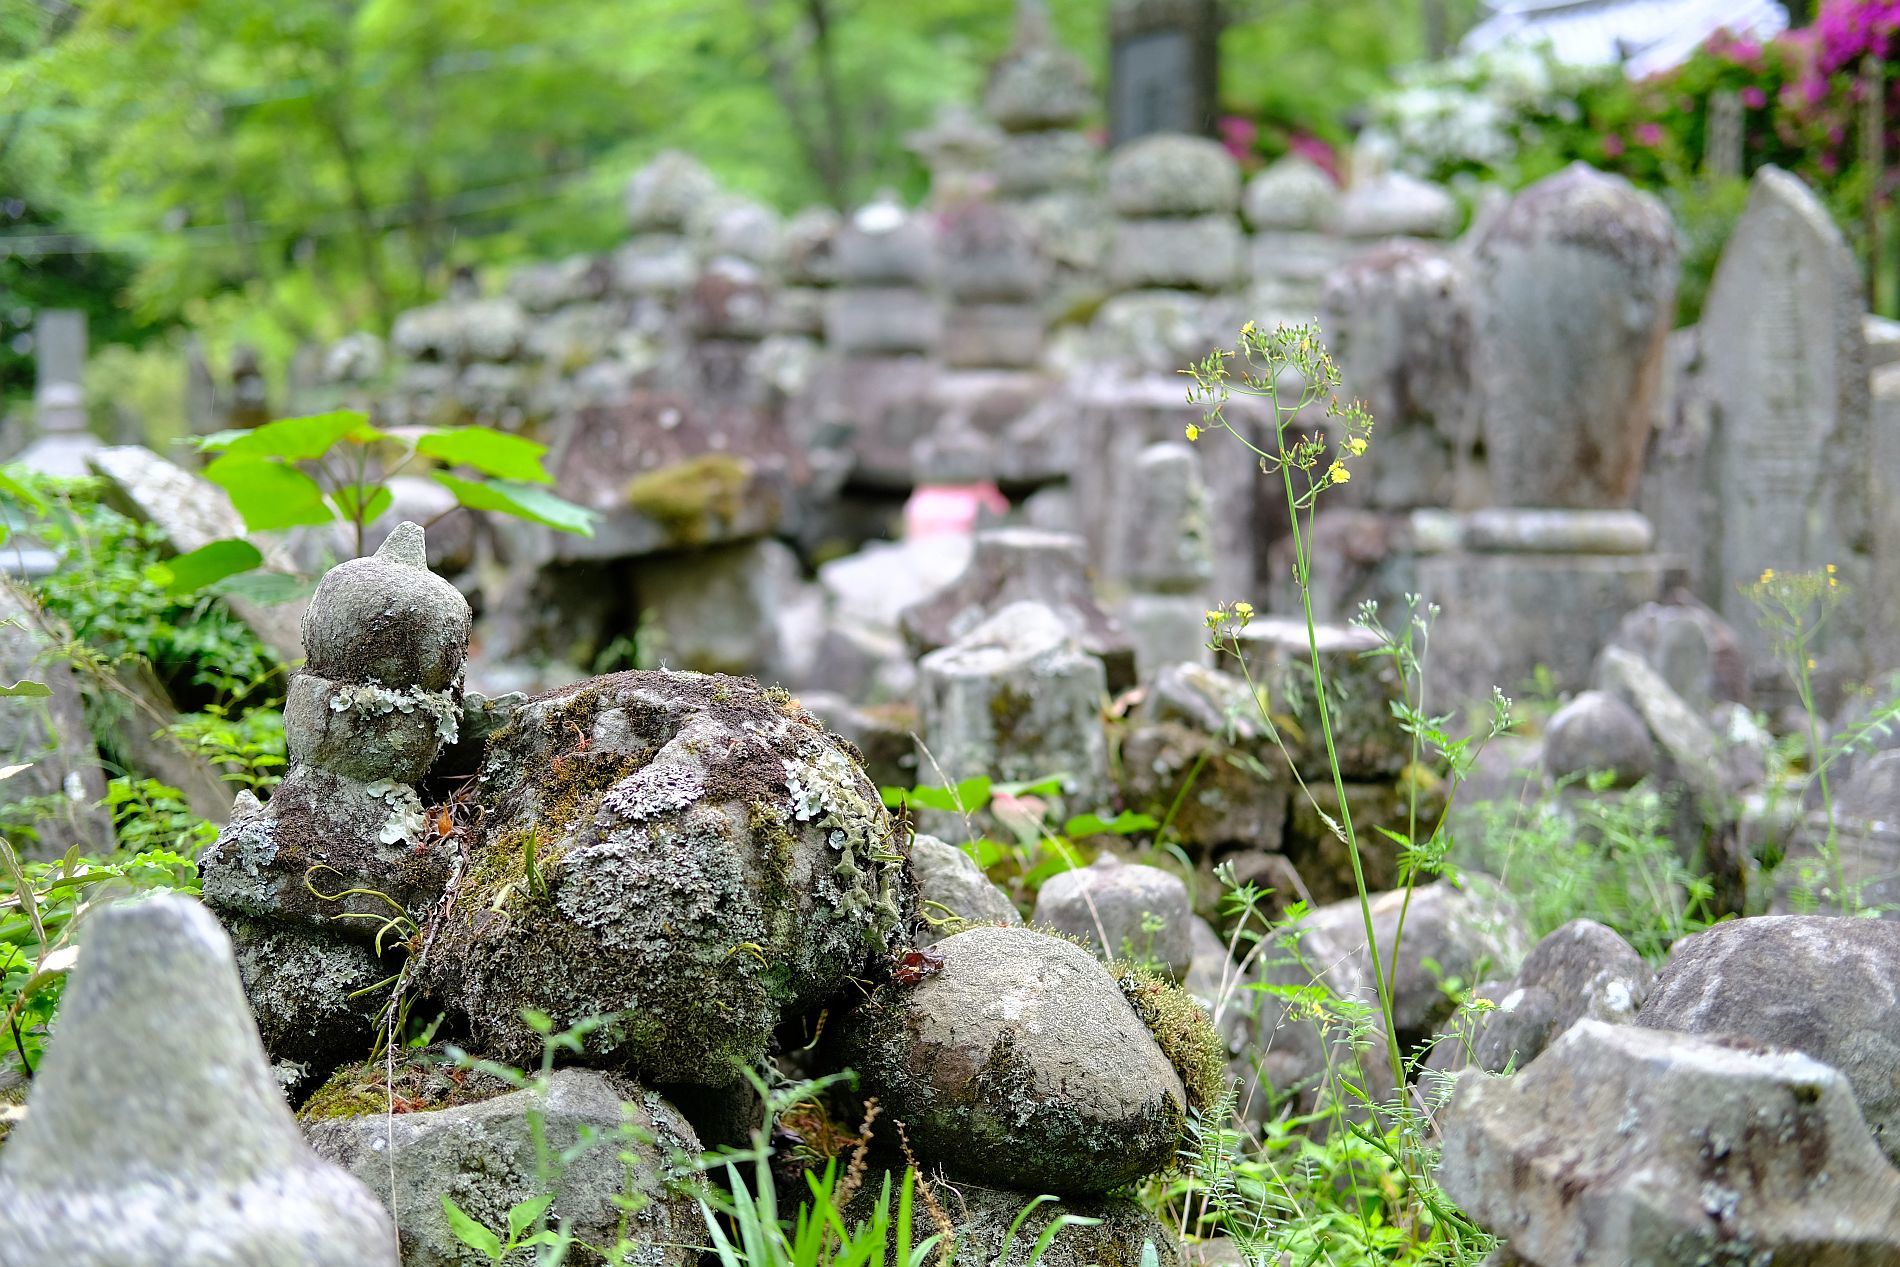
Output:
[1413, 163, 1676, 697]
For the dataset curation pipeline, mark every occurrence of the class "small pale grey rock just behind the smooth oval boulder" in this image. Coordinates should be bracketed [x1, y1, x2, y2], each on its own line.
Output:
[1032, 853, 1193, 980]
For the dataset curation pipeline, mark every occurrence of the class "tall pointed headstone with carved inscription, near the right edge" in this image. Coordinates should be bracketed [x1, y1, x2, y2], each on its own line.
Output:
[1699, 167, 1887, 676]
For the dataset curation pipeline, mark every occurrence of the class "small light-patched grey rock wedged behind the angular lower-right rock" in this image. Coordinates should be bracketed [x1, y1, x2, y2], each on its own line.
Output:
[1431, 919, 1657, 1073]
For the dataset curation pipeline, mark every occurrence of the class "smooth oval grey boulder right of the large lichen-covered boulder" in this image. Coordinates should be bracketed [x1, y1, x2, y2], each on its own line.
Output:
[838, 927, 1188, 1197]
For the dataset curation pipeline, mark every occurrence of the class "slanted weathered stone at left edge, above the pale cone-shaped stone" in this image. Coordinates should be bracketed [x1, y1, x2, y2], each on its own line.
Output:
[0, 577, 114, 859]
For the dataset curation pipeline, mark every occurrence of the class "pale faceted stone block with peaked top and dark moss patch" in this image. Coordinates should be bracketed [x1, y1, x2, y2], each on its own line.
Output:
[918, 602, 1110, 832]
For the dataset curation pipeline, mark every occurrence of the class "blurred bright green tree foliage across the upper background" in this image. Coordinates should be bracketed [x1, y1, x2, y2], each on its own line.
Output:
[0, 0, 1469, 406]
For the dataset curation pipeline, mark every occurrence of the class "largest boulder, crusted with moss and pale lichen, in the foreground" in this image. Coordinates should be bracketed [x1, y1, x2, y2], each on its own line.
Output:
[428, 671, 910, 1085]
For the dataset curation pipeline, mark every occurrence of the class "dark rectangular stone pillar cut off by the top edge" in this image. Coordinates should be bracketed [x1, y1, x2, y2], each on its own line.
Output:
[1108, 0, 1220, 144]
